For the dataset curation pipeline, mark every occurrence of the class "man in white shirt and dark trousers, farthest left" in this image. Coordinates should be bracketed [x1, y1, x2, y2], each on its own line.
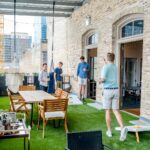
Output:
[38, 63, 48, 92]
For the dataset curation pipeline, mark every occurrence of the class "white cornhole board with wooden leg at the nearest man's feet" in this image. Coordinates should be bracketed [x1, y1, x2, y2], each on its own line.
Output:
[116, 125, 150, 143]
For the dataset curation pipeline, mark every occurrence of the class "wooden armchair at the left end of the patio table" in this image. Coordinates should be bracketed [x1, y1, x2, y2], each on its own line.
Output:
[7, 89, 31, 115]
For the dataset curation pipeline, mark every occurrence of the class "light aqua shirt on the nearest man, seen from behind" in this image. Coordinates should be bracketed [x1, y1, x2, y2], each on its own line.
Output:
[101, 64, 118, 88]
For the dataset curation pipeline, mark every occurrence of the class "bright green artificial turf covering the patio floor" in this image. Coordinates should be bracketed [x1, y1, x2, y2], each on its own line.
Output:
[0, 97, 150, 150]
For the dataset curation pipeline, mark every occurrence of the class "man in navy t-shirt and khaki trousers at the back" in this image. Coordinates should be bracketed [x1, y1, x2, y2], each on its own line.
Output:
[55, 62, 63, 89]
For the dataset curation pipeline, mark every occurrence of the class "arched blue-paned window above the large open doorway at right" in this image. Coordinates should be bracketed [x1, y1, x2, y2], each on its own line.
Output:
[121, 20, 144, 38]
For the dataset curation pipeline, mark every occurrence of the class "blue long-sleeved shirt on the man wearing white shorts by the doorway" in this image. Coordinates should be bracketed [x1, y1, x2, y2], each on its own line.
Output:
[77, 62, 90, 79]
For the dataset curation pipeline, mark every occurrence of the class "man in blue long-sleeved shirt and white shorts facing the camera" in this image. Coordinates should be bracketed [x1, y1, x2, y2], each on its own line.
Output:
[77, 56, 89, 99]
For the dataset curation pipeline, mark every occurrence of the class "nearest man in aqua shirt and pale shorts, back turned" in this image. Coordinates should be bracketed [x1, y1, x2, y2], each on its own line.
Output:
[100, 53, 128, 141]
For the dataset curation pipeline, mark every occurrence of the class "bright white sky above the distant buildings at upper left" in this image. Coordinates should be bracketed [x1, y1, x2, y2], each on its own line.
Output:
[4, 15, 34, 38]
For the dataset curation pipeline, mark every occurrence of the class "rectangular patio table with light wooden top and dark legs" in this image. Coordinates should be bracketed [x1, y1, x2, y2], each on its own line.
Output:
[19, 90, 57, 127]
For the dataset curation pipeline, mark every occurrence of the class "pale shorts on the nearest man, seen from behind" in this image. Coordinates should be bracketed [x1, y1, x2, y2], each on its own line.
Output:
[103, 89, 119, 110]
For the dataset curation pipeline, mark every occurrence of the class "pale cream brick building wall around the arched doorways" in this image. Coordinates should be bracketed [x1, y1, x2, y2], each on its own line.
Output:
[48, 0, 150, 118]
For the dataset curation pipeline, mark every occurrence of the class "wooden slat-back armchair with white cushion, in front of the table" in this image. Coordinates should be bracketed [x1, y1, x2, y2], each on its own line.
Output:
[38, 99, 68, 138]
